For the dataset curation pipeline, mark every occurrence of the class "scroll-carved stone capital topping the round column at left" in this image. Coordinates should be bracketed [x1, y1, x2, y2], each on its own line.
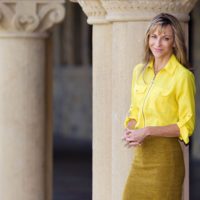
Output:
[0, 0, 65, 36]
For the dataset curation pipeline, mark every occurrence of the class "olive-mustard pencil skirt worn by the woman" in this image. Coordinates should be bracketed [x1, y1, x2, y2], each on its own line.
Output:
[123, 136, 185, 200]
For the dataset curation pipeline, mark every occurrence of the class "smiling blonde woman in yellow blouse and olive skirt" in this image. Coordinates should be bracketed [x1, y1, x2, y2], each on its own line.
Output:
[123, 13, 195, 200]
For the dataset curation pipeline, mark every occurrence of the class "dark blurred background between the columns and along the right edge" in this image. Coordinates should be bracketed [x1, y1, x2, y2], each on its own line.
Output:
[53, 1, 200, 200]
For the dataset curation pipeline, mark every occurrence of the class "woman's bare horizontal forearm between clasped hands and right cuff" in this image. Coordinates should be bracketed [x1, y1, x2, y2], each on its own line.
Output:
[145, 124, 180, 137]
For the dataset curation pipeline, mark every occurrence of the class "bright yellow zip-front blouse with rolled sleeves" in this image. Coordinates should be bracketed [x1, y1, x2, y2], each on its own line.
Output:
[125, 55, 196, 144]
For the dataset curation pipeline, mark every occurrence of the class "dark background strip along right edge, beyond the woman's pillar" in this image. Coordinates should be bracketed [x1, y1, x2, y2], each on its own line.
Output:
[190, 1, 200, 200]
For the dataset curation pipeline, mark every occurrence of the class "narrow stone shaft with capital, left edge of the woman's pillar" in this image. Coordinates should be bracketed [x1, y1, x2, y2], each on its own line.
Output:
[70, 0, 112, 200]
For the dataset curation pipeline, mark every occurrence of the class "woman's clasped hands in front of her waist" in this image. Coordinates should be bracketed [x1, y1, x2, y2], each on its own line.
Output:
[122, 128, 147, 148]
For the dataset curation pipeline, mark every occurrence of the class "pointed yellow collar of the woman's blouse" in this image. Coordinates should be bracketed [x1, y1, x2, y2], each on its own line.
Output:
[147, 54, 179, 74]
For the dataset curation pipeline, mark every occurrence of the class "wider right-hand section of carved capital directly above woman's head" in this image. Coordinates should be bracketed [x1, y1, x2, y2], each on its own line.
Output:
[101, 0, 197, 21]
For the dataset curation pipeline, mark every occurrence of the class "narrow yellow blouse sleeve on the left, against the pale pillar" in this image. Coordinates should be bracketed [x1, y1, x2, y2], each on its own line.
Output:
[124, 66, 138, 127]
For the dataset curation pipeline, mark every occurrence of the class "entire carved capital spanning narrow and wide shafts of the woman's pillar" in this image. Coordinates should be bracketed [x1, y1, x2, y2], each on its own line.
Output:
[71, 0, 197, 24]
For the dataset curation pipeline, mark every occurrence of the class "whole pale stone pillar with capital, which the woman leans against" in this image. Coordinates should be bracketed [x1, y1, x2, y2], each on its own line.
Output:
[73, 0, 196, 200]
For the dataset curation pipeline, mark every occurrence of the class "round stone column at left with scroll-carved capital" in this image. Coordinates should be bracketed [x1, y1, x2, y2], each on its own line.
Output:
[0, 0, 65, 200]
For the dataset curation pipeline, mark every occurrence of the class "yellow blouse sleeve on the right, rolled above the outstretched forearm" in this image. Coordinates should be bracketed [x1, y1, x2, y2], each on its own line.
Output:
[176, 72, 196, 144]
